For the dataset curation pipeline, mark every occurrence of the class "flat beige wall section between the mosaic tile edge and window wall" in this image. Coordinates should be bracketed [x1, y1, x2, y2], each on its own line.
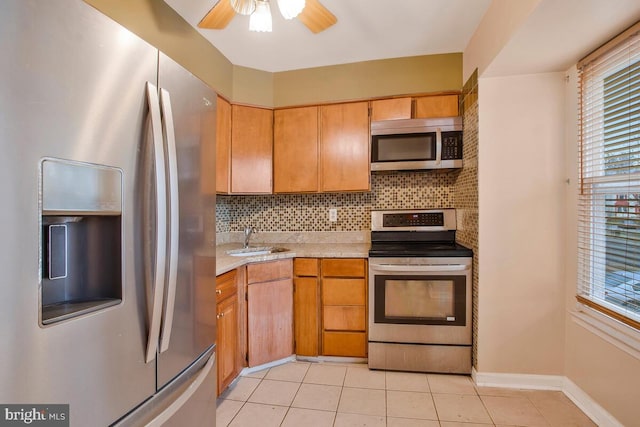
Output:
[476, 73, 565, 375]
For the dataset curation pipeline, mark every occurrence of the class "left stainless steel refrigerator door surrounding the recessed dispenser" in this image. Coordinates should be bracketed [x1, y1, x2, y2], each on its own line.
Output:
[0, 0, 157, 426]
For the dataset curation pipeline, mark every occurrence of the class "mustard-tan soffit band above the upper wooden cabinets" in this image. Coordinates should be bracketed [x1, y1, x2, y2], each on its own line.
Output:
[85, 0, 462, 107]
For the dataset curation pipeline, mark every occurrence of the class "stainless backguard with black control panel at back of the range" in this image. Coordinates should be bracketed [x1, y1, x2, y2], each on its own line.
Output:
[371, 209, 456, 231]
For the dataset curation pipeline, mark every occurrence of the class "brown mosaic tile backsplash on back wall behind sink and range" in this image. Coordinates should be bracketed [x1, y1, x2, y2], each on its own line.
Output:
[215, 170, 460, 233]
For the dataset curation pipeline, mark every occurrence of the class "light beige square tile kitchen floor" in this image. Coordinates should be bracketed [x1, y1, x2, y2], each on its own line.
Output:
[216, 361, 595, 427]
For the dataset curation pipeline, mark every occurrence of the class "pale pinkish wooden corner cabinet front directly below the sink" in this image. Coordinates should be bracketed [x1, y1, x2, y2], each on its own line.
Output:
[247, 259, 293, 367]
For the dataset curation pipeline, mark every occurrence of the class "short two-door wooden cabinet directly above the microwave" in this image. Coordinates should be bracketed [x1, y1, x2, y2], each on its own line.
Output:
[371, 95, 458, 121]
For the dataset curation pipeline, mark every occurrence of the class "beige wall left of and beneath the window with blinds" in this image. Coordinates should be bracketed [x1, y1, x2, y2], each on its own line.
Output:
[564, 67, 640, 426]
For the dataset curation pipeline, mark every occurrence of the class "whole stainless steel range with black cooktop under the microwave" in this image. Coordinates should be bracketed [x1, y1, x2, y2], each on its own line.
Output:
[368, 209, 473, 374]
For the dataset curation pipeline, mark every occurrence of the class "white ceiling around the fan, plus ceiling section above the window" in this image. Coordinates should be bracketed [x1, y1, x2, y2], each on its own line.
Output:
[165, 0, 640, 77]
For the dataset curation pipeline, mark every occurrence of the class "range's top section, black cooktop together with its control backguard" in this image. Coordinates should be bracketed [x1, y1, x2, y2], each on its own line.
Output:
[369, 209, 473, 257]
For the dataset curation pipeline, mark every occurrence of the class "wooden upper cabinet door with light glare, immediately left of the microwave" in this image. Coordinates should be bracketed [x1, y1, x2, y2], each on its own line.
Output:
[320, 102, 370, 191]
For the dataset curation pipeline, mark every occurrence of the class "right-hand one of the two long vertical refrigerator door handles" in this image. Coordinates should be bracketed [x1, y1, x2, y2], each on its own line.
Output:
[160, 88, 180, 353]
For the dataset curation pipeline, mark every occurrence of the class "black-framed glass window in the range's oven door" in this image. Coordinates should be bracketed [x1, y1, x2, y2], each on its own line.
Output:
[374, 275, 466, 326]
